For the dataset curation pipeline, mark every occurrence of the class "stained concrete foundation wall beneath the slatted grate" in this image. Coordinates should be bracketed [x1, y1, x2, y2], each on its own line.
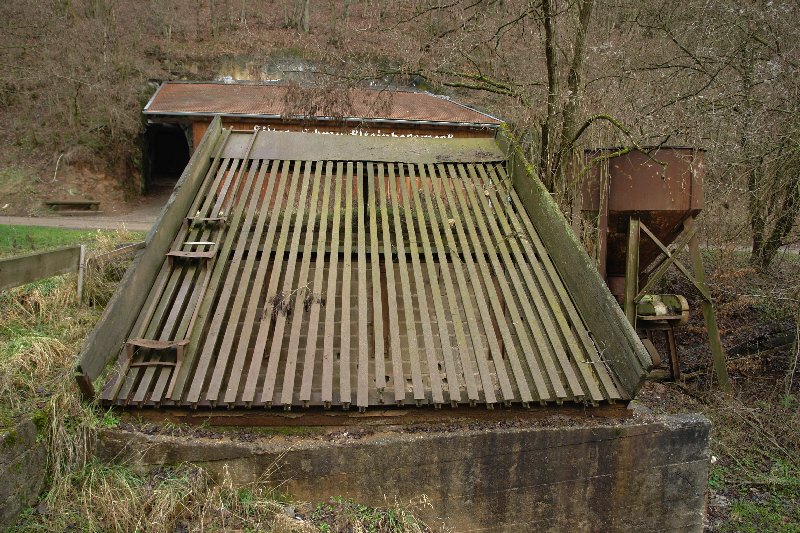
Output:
[98, 415, 710, 532]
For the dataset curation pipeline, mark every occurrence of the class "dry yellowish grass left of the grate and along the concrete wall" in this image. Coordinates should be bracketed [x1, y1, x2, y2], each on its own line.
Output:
[0, 226, 429, 533]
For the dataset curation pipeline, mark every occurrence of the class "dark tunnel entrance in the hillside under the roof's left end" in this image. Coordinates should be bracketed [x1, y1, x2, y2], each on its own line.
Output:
[146, 124, 191, 195]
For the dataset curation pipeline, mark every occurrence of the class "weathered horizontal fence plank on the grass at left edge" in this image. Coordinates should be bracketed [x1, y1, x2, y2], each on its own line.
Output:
[0, 246, 81, 291]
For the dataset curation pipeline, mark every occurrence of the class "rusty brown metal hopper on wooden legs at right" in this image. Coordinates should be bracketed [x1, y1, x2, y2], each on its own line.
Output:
[582, 147, 704, 294]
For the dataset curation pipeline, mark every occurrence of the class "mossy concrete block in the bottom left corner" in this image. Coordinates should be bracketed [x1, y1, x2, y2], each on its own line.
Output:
[0, 420, 47, 528]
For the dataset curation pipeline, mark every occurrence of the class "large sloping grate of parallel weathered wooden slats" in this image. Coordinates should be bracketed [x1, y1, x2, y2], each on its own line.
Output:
[102, 136, 621, 408]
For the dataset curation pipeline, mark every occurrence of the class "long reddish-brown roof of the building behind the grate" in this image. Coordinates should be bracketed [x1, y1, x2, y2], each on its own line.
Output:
[144, 82, 501, 125]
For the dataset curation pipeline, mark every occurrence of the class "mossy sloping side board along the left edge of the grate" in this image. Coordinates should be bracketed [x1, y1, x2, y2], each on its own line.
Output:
[77, 119, 227, 386]
